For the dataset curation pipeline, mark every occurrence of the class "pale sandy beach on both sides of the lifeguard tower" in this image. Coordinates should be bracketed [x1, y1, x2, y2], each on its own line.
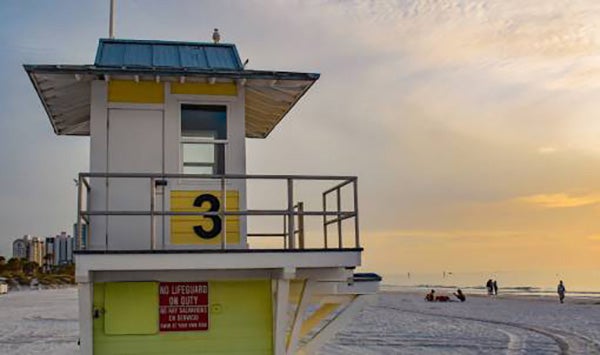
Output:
[0, 288, 600, 355]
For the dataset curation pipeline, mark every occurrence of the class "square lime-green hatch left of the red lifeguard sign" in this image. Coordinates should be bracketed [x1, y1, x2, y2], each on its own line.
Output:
[104, 282, 158, 335]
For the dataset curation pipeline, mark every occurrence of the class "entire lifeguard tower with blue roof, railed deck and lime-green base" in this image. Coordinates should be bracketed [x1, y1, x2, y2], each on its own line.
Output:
[25, 34, 380, 355]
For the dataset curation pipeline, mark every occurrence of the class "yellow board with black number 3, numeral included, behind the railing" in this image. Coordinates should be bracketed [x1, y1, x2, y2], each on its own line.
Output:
[170, 190, 240, 245]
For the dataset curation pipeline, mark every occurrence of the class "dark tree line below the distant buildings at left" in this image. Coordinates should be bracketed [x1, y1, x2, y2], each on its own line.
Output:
[0, 255, 75, 287]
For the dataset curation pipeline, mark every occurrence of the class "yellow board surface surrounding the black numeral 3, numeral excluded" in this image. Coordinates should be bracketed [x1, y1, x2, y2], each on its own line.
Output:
[171, 191, 240, 245]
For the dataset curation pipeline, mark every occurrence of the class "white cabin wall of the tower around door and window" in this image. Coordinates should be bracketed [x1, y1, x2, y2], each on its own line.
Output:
[88, 80, 246, 249]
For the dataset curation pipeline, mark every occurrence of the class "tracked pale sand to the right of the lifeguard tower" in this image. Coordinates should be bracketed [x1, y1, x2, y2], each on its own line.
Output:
[321, 292, 600, 355]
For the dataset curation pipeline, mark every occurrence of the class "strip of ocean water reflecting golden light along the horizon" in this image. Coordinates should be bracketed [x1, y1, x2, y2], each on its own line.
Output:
[382, 269, 600, 298]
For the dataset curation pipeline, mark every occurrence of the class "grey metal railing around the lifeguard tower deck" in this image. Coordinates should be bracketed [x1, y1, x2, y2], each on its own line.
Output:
[77, 173, 360, 250]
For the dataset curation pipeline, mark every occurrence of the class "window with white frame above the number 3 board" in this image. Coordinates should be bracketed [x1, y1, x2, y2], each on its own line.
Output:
[181, 105, 227, 174]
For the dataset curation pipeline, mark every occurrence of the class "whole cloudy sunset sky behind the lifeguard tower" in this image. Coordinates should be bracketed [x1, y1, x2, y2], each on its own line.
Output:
[0, 0, 600, 273]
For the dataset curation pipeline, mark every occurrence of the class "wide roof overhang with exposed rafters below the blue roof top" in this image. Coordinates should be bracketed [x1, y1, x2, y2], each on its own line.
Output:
[24, 65, 319, 138]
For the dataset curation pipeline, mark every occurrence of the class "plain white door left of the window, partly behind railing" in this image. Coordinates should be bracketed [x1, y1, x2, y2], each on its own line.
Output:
[107, 109, 163, 249]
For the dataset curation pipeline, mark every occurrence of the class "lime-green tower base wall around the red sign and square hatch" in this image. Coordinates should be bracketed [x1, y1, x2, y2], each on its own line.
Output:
[93, 280, 273, 355]
